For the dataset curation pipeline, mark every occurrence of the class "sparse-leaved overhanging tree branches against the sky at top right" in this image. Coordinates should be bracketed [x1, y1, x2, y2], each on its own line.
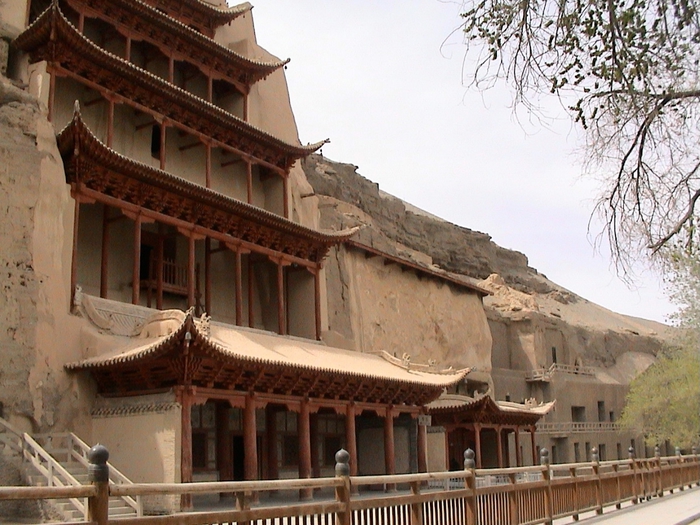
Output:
[462, 0, 700, 271]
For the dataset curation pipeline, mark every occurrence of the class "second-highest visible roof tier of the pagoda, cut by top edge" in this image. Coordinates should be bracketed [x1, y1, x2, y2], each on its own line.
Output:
[67, 0, 289, 92]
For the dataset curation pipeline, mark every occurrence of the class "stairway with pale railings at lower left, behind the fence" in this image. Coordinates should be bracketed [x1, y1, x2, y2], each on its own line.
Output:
[0, 418, 142, 521]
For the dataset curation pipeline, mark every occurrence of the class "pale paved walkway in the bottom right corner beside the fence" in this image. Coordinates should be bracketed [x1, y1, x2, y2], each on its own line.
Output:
[554, 487, 700, 525]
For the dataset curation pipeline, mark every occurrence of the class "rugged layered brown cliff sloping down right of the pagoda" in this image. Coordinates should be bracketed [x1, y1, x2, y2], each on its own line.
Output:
[304, 155, 670, 376]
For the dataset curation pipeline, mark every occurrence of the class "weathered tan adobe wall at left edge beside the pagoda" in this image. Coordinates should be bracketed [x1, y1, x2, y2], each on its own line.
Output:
[0, 77, 89, 434]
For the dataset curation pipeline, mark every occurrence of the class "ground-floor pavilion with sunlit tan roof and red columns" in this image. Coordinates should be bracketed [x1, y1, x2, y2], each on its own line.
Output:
[67, 308, 468, 497]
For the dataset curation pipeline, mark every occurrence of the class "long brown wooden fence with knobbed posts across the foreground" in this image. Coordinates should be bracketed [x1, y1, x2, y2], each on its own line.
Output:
[0, 445, 700, 525]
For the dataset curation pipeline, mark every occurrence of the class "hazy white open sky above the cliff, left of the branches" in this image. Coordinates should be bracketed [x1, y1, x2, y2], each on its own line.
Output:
[253, 0, 673, 321]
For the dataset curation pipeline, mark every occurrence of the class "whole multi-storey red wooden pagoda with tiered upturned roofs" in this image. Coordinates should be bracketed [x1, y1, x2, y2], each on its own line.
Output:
[14, 0, 474, 508]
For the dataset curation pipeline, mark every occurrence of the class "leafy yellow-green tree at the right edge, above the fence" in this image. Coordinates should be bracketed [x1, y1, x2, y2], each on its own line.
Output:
[620, 251, 700, 448]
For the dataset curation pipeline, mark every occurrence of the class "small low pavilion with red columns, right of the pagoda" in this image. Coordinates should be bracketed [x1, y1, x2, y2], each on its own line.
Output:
[426, 394, 555, 469]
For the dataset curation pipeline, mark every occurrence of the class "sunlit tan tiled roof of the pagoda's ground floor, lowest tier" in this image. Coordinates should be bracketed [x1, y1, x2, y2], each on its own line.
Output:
[66, 310, 468, 406]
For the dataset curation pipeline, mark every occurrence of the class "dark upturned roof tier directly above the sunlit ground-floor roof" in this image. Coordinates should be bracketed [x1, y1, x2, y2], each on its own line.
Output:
[58, 108, 355, 262]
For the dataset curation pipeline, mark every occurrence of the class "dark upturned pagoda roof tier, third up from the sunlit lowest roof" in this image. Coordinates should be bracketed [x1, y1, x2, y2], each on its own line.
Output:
[14, 4, 326, 172]
